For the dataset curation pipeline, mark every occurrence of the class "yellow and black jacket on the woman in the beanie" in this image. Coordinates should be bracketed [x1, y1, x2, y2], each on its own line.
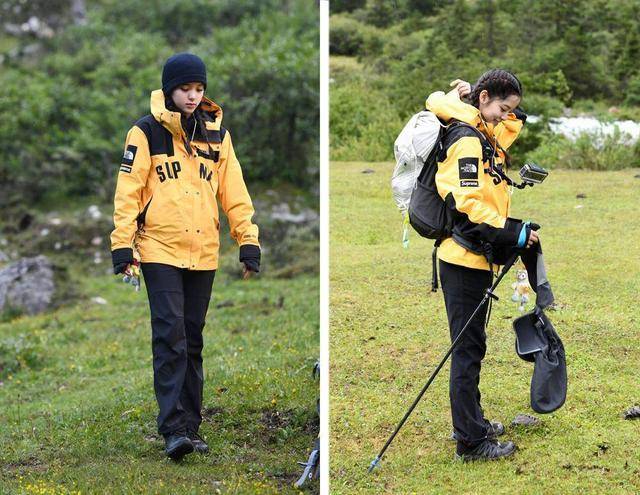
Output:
[111, 90, 259, 270]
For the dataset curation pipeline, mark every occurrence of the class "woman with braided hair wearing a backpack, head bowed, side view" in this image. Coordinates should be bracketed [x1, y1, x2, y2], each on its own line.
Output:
[426, 69, 538, 460]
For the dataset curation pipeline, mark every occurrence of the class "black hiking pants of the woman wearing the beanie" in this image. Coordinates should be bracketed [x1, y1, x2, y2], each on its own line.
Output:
[142, 263, 216, 436]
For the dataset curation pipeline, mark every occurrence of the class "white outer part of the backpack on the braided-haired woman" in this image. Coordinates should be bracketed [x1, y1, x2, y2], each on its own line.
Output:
[391, 110, 443, 248]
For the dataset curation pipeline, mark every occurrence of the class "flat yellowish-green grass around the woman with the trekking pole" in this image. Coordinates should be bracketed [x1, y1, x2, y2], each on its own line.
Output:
[330, 162, 640, 494]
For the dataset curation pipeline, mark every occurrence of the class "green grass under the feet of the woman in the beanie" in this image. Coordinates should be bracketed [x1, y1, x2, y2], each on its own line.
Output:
[0, 272, 319, 494]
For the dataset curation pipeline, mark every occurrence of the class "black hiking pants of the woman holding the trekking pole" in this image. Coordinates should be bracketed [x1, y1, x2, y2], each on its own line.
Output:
[440, 260, 492, 451]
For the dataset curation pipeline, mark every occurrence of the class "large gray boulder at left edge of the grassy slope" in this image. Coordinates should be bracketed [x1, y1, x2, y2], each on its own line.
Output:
[0, 256, 55, 315]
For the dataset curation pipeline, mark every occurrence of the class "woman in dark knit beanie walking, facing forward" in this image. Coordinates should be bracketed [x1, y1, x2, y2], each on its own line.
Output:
[111, 53, 260, 459]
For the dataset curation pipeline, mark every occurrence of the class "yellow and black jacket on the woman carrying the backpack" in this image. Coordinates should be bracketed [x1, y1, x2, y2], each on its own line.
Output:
[426, 89, 523, 270]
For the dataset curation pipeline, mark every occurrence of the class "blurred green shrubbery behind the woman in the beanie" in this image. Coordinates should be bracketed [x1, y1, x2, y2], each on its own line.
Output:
[0, 0, 319, 206]
